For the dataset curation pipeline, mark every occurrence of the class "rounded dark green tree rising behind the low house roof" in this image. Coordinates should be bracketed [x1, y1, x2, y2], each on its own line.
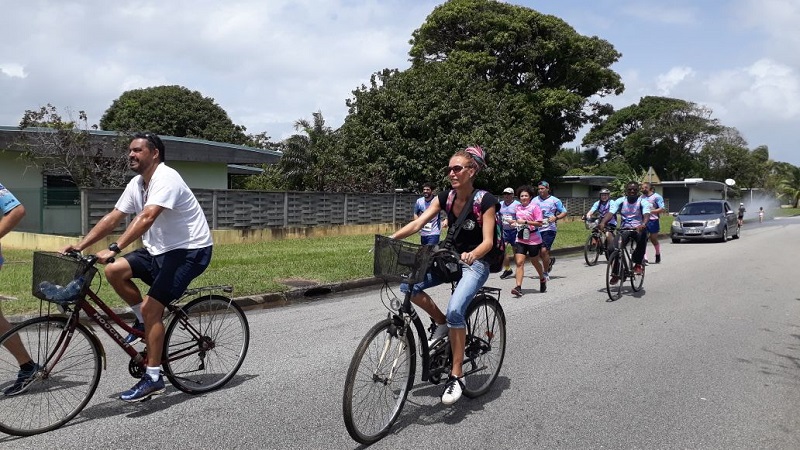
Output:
[100, 86, 251, 145]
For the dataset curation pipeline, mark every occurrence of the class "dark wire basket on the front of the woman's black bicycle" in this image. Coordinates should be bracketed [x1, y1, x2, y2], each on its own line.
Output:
[373, 234, 432, 284]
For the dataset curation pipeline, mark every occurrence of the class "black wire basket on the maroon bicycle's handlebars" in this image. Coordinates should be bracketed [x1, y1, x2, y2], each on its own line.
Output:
[31, 252, 97, 303]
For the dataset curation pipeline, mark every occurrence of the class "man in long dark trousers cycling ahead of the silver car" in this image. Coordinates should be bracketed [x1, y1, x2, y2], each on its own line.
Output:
[598, 181, 650, 284]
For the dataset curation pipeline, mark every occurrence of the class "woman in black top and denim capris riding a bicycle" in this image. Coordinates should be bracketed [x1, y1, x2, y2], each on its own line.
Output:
[391, 146, 497, 405]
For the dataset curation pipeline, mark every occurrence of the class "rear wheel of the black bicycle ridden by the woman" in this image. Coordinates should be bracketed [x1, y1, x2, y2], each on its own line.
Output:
[462, 295, 506, 398]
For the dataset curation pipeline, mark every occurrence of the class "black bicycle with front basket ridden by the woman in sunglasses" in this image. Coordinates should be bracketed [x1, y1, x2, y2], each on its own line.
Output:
[342, 235, 506, 445]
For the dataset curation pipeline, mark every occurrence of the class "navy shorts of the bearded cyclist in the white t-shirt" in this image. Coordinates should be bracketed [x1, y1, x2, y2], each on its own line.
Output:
[123, 246, 212, 305]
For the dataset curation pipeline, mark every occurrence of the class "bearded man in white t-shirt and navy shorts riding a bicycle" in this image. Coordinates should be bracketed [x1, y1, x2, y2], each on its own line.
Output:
[61, 133, 213, 402]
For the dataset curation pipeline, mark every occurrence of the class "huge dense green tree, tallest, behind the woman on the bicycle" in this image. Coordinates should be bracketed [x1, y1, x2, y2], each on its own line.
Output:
[341, 0, 623, 189]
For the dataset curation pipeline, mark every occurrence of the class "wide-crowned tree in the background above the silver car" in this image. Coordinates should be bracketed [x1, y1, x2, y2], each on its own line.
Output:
[583, 97, 725, 180]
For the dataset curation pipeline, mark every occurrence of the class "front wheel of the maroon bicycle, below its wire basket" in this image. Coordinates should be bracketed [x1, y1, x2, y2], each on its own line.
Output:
[0, 317, 102, 436]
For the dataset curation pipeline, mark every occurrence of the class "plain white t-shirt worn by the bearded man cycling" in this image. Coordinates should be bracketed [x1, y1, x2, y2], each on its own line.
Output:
[114, 163, 213, 256]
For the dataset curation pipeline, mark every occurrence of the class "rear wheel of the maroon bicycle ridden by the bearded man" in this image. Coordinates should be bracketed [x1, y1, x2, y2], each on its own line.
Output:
[163, 295, 250, 394]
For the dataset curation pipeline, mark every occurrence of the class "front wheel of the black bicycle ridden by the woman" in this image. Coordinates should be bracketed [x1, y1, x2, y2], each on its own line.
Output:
[342, 319, 417, 445]
